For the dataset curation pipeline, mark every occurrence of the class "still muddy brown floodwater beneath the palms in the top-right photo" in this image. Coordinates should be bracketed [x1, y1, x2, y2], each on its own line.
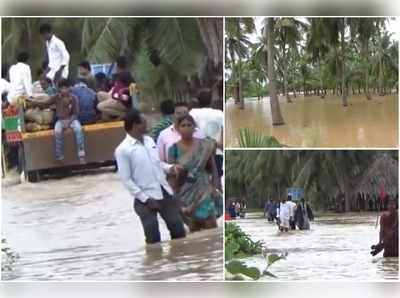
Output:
[225, 95, 398, 148]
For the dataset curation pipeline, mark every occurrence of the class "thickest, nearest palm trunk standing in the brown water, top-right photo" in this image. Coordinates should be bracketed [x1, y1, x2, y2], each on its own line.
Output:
[264, 18, 285, 125]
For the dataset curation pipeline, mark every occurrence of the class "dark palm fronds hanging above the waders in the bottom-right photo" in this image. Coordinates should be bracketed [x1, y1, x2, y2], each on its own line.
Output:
[225, 150, 398, 211]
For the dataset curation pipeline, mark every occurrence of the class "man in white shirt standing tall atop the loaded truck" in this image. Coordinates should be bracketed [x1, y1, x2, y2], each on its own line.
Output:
[39, 24, 70, 84]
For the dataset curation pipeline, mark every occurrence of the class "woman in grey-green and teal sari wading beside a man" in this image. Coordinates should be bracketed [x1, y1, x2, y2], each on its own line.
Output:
[168, 115, 223, 232]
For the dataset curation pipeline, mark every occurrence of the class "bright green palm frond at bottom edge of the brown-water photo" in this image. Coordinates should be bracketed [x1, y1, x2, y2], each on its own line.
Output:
[239, 128, 283, 148]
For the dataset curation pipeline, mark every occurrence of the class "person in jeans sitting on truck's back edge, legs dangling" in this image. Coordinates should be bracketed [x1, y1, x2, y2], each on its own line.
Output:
[34, 79, 85, 163]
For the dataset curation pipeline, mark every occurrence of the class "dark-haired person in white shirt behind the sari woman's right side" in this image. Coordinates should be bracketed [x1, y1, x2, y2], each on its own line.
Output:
[189, 90, 224, 177]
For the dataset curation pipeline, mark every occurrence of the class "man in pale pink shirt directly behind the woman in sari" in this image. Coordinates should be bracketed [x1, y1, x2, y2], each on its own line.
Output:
[157, 103, 205, 162]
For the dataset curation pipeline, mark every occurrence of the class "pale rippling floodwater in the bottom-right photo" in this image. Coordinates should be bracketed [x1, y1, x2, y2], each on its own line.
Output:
[235, 213, 399, 281]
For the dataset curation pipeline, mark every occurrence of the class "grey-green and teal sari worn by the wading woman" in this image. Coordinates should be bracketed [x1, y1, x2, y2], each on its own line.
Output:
[168, 139, 223, 221]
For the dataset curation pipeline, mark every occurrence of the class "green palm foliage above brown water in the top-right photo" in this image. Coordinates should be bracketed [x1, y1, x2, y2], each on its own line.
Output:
[225, 17, 398, 103]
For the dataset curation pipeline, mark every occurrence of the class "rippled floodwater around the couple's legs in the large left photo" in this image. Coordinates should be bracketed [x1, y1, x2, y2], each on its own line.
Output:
[2, 172, 223, 281]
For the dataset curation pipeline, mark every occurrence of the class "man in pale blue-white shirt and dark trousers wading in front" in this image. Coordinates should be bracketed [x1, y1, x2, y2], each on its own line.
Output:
[115, 110, 185, 243]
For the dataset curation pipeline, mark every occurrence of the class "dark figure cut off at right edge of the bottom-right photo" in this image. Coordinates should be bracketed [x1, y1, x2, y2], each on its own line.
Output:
[371, 198, 399, 258]
